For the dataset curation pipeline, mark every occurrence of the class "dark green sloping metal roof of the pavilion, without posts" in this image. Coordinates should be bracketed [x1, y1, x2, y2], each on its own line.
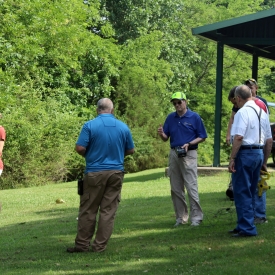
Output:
[192, 8, 275, 60]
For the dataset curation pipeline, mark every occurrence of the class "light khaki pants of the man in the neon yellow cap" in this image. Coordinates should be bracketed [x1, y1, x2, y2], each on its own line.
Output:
[168, 149, 203, 223]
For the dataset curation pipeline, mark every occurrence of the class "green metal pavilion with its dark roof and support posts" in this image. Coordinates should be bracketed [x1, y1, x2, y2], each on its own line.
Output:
[192, 8, 275, 166]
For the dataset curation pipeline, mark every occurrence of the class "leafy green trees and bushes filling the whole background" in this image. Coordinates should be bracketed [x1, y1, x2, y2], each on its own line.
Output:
[0, 0, 275, 188]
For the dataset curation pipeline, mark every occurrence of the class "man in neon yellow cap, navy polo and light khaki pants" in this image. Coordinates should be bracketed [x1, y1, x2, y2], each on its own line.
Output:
[158, 92, 207, 227]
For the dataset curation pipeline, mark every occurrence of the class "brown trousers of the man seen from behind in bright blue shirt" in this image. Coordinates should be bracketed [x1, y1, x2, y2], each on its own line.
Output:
[75, 170, 124, 252]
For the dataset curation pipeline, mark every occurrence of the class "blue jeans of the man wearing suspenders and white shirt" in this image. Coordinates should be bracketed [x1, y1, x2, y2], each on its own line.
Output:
[232, 149, 263, 236]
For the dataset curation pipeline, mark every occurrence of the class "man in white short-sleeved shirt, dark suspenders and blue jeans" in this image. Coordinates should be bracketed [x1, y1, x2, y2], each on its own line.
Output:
[228, 85, 273, 237]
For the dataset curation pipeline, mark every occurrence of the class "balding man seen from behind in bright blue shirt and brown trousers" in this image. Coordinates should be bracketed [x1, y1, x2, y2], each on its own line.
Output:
[67, 98, 134, 253]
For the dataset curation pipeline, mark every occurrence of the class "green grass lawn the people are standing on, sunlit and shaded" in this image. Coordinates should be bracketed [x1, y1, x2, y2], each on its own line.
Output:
[0, 169, 275, 275]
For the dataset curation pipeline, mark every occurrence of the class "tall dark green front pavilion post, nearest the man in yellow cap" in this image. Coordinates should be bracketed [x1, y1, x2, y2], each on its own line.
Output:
[213, 41, 224, 167]
